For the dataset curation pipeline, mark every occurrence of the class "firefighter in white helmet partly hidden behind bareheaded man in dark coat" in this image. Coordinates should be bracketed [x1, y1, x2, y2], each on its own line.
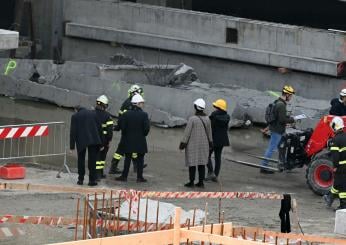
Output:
[95, 95, 114, 181]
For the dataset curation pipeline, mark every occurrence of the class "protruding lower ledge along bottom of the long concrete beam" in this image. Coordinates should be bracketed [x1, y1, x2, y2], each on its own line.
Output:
[66, 23, 341, 77]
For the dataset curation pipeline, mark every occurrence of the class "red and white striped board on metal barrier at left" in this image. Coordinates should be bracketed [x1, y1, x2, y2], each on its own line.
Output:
[0, 125, 48, 139]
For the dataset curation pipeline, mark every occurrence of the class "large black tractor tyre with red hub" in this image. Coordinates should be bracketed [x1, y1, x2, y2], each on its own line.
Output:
[306, 158, 334, 196]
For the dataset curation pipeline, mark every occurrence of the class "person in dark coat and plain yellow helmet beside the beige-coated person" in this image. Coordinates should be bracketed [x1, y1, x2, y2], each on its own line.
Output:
[206, 99, 231, 182]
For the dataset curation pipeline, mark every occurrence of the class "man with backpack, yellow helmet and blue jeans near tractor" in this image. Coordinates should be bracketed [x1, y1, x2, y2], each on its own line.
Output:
[260, 85, 295, 174]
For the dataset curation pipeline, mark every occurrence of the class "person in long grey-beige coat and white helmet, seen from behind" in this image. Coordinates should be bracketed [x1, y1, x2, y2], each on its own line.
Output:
[179, 99, 213, 188]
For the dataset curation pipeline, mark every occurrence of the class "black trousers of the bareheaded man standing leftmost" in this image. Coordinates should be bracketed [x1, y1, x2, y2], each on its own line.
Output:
[78, 145, 100, 182]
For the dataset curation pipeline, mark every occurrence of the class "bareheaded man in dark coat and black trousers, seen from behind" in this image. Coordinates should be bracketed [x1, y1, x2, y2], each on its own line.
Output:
[70, 108, 102, 186]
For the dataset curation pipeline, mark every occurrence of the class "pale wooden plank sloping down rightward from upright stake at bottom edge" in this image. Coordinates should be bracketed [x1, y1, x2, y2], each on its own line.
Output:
[180, 230, 262, 245]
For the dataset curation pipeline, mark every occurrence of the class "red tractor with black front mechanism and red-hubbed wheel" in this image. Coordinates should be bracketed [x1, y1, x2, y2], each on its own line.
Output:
[279, 115, 346, 195]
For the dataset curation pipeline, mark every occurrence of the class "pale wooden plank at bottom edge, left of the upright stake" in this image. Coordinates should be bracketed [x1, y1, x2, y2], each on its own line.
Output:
[50, 230, 173, 245]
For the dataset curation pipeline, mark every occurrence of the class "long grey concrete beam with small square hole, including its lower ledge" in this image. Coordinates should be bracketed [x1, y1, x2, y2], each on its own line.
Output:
[64, 0, 346, 76]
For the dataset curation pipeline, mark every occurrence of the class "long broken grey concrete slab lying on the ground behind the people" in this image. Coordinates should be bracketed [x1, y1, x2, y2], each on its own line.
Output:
[0, 59, 330, 128]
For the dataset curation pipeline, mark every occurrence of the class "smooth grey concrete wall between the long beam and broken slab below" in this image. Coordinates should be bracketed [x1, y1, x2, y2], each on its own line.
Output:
[64, 38, 346, 100]
